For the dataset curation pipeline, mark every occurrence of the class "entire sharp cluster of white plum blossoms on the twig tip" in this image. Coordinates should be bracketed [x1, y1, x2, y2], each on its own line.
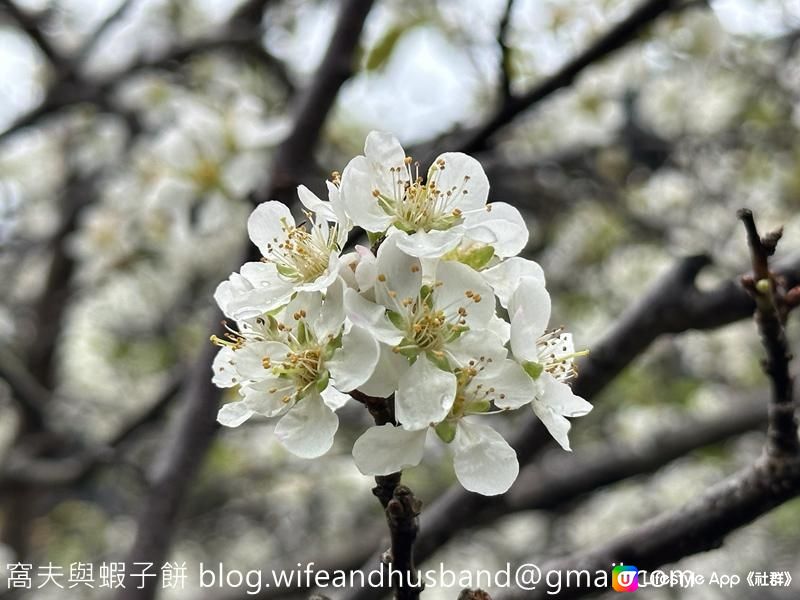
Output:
[212, 132, 591, 495]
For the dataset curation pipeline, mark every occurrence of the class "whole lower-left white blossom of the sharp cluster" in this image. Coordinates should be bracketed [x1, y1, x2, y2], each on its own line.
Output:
[213, 280, 378, 458]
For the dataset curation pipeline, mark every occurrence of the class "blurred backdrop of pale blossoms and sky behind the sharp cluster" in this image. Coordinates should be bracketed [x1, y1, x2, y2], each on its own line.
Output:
[0, 0, 800, 600]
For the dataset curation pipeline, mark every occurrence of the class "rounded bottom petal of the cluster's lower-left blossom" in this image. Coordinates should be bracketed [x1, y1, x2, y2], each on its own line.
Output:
[275, 394, 339, 458]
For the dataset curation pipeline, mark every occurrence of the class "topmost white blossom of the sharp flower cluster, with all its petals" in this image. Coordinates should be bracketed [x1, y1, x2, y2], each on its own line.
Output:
[342, 131, 528, 258]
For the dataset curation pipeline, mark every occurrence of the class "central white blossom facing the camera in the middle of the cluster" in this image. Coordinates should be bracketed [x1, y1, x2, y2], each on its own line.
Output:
[345, 236, 495, 430]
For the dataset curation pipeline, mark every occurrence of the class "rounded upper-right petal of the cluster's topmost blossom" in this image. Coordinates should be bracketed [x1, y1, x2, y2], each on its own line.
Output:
[428, 152, 489, 212]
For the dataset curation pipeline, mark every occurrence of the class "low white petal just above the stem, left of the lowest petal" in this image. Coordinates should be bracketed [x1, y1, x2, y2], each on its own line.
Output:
[353, 425, 427, 475]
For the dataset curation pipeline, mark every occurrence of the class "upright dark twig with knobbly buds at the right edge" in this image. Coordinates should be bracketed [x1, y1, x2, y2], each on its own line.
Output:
[738, 209, 800, 455]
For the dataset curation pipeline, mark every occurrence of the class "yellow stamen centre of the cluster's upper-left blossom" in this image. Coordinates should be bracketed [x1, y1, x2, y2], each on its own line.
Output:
[263, 212, 339, 283]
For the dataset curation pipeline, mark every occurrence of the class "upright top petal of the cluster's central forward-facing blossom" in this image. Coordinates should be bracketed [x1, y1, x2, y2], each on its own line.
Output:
[375, 235, 422, 310]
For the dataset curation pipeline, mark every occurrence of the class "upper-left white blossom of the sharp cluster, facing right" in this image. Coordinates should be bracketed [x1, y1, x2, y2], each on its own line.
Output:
[214, 185, 349, 319]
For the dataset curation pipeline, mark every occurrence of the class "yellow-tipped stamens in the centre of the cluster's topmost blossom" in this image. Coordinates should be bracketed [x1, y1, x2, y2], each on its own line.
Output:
[372, 156, 469, 233]
